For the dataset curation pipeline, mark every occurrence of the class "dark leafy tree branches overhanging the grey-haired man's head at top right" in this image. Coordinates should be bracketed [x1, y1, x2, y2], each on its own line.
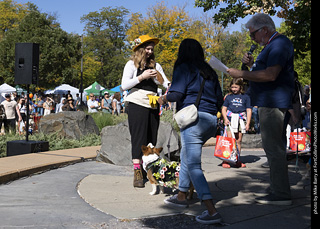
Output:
[195, 0, 311, 54]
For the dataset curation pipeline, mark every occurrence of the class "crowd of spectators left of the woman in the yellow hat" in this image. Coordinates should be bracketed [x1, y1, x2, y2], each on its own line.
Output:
[0, 88, 130, 134]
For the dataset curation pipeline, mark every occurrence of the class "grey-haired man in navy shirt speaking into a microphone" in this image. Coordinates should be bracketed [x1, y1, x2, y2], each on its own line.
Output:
[228, 13, 294, 205]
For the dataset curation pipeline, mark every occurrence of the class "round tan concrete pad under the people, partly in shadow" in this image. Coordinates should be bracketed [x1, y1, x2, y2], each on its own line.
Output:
[78, 147, 310, 228]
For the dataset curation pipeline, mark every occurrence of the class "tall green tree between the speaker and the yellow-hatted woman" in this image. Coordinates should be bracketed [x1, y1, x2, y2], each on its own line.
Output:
[81, 7, 129, 88]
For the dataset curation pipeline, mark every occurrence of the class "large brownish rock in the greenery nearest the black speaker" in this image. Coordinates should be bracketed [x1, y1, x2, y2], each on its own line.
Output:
[39, 111, 99, 140]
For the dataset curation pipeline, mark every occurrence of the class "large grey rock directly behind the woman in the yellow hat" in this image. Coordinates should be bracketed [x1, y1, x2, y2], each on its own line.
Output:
[97, 121, 180, 165]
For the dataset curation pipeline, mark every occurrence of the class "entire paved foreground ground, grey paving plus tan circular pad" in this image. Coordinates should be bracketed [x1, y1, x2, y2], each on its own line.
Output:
[0, 147, 311, 229]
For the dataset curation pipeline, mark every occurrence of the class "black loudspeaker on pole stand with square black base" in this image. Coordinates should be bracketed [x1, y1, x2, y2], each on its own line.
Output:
[7, 43, 49, 156]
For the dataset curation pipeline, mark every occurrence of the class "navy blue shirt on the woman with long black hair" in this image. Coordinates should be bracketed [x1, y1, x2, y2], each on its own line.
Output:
[167, 64, 223, 115]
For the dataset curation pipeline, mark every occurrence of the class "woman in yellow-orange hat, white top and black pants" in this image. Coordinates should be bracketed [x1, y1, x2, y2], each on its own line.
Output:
[121, 35, 170, 188]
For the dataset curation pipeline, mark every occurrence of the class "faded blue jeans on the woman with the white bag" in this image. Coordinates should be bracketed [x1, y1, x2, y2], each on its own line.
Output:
[179, 112, 217, 200]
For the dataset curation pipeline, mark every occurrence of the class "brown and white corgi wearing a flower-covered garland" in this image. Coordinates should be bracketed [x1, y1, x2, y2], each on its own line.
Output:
[141, 143, 194, 200]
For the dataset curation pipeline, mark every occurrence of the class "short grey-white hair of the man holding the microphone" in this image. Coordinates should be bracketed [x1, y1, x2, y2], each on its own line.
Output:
[245, 13, 276, 32]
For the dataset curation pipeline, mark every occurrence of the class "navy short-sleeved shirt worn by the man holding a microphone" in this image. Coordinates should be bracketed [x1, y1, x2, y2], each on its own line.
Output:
[250, 35, 294, 109]
